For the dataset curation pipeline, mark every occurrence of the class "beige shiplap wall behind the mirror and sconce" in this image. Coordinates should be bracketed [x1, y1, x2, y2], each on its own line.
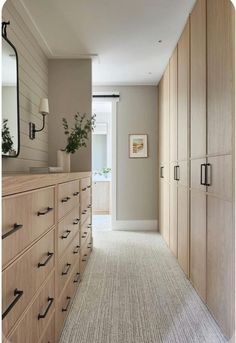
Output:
[2, 0, 48, 172]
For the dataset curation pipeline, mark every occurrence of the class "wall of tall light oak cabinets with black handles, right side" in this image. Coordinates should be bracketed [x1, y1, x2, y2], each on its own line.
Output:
[159, 0, 235, 338]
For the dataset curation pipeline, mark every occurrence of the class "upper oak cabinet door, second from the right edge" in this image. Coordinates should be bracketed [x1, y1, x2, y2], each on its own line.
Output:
[190, 0, 206, 157]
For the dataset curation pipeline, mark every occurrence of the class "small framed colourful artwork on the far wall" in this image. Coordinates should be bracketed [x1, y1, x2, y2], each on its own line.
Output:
[129, 134, 148, 158]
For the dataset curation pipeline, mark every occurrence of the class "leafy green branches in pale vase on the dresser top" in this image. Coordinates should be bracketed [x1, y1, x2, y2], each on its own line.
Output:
[57, 112, 96, 172]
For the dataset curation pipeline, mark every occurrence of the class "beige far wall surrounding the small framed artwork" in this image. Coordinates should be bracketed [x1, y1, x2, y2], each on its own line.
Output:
[93, 86, 158, 220]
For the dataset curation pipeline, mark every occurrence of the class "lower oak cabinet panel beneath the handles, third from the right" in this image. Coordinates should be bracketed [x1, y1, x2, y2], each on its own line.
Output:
[178, 186, 189, 275]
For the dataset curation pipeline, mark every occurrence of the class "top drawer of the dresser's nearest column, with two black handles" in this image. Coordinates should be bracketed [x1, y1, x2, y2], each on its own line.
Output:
[2, 187, 55, 266]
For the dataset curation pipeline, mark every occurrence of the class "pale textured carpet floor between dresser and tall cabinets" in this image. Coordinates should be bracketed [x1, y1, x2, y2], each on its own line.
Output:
[60, 231, 226, 343]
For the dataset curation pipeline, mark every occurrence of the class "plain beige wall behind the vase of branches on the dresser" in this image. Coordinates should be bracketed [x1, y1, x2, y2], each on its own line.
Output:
[49, 59, 92, 171]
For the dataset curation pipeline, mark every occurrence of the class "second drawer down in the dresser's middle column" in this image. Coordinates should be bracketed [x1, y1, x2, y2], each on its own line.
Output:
[58, 208, 80, 257]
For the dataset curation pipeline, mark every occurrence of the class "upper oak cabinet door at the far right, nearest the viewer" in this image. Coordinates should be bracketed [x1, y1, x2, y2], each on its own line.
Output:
[207, 0, 235, 155]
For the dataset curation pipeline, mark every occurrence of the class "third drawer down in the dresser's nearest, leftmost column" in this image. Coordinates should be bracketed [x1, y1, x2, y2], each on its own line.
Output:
[9, 273, 55, 343]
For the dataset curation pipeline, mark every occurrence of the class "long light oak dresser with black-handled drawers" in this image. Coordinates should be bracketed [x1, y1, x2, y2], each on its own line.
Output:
[2, 172, 93, 343]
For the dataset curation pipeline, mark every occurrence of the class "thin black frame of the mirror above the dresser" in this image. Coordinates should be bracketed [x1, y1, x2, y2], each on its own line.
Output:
[2, 21, 20, 158]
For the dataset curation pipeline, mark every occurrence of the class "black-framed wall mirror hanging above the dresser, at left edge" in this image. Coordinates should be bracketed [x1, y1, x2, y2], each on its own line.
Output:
[2, 22, 20, 157]
